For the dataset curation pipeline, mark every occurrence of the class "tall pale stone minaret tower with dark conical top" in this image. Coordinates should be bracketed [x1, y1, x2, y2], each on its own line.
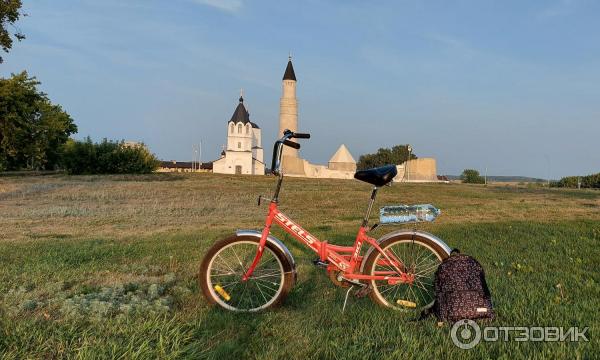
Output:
[279, 55, 298, 157]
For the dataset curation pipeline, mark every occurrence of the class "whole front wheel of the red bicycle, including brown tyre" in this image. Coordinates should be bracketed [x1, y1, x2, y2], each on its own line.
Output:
[199, 236, 293, 312]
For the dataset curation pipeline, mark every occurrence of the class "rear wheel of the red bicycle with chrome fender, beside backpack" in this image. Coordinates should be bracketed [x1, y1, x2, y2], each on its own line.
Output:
[363, 235, 449, 313]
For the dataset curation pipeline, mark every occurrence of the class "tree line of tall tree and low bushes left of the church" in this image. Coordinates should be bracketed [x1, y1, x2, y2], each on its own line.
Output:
[0, 71, 159, 174]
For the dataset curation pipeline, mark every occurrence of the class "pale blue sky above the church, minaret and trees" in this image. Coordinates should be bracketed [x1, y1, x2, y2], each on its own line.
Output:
[0, 0, 600, 178]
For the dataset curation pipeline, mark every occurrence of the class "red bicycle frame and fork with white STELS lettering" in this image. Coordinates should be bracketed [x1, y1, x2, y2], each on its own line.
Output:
[242, 201, 414, 284]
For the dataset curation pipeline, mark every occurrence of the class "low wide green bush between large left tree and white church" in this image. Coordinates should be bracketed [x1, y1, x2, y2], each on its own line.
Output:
[62, 137, 159, 174]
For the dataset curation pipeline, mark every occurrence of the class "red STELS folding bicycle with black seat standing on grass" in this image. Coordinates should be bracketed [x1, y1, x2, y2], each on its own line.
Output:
[199, 130, 451, 312]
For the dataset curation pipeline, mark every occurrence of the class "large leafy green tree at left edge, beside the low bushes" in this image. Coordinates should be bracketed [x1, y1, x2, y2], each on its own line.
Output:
[0, 71, 77, 170]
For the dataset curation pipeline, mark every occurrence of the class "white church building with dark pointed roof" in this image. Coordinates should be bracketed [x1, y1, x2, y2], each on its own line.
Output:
[213, 96, 265, 175]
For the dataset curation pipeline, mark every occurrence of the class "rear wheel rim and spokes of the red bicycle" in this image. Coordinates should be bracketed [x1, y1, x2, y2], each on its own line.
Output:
[371, 239, 442, 312]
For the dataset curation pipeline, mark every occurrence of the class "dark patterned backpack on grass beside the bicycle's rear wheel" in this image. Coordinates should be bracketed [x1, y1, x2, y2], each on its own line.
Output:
[432, 250, 495, 322]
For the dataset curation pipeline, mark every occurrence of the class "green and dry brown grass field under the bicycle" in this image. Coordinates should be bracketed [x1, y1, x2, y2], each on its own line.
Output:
[0, 174, 600, 359]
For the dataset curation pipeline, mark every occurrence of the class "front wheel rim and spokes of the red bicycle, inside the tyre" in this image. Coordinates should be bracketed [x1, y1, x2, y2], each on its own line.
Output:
[206, 241, 285, 311]
